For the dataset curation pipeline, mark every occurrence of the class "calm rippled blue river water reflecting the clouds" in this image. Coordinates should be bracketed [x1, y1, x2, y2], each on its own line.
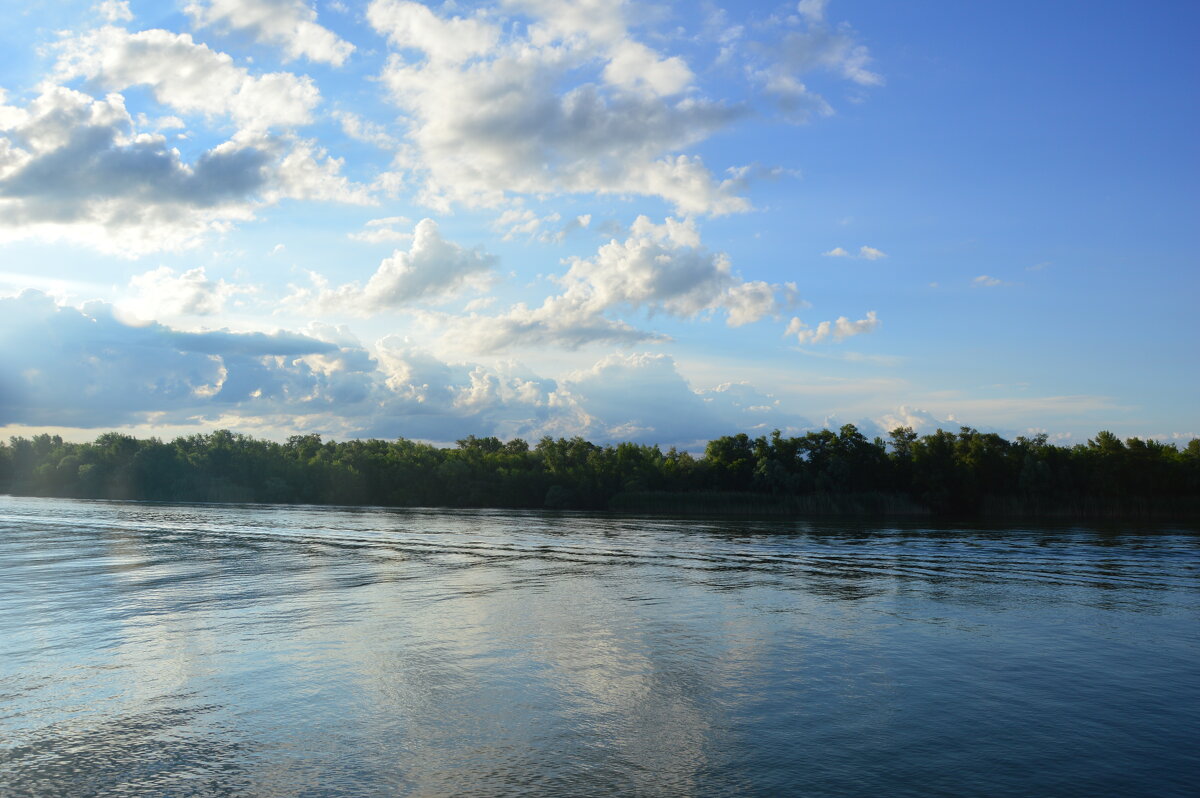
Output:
[0, 497, 1200, 798]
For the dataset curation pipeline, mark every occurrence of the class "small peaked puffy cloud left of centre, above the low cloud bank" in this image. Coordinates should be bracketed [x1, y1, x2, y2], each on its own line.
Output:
[287, 218, 496, 313]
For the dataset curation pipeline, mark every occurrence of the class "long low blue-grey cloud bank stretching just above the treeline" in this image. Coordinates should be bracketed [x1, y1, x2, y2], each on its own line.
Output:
[0, 292, 804, 446]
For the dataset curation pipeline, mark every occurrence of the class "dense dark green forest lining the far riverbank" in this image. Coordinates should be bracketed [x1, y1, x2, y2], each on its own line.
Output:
[0, 425, 1200, 518]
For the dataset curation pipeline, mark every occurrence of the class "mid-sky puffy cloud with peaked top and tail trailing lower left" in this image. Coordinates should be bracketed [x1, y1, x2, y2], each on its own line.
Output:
[441, 216, 796, 352]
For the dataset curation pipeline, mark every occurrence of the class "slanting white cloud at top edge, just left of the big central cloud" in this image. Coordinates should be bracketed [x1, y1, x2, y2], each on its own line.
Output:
[184, 0, 354, 66]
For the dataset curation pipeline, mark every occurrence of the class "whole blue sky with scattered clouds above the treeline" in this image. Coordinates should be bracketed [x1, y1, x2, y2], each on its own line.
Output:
[0, 0, 1200, 450]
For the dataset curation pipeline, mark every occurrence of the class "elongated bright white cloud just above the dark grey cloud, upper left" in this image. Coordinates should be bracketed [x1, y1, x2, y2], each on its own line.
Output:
[55, 26, 320, 131]
